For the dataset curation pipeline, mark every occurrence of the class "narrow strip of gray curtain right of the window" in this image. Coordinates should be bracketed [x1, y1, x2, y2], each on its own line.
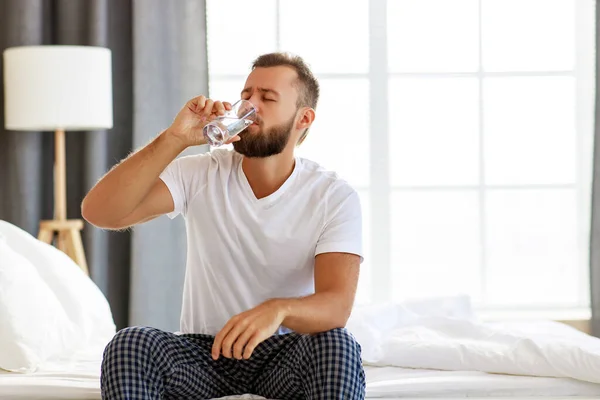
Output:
[590, 2, 600, 337]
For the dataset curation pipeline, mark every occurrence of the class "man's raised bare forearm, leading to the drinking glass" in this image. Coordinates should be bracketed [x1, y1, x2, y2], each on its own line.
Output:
[81, 131, 185, 224]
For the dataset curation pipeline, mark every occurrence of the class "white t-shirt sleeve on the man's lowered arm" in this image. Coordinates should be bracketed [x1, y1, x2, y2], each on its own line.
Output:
[315, 190, 363, 263]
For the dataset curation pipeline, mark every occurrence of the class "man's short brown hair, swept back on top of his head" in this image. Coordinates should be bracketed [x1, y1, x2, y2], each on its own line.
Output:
[252, 52, 320, 144]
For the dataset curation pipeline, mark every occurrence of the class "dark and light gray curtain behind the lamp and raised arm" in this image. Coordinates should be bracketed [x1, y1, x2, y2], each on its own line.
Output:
[0, 0, 208, 330]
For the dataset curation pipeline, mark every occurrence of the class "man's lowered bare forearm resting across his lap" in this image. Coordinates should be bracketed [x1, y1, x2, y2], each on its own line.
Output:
[276, 292, 352, 333]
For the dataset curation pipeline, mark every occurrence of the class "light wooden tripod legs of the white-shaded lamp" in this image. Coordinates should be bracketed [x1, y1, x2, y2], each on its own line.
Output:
[38, 219, 89, 275]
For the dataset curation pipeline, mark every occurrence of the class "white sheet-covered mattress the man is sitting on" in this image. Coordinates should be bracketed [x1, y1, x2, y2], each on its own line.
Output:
[0, 357, 600, 400]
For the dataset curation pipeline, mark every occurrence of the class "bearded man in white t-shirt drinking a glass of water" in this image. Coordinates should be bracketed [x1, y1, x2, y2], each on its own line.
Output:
[82, 53, 365, 400]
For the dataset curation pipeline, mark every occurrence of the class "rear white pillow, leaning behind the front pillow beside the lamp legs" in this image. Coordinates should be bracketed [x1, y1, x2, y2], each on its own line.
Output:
[0, 220, 116, 356]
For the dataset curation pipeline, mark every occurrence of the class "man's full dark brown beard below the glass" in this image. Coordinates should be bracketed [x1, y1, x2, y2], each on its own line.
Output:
[233, 116, 295, 158]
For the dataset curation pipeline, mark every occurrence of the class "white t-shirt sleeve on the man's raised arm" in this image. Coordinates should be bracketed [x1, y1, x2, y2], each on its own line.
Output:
[160, 154, 210, 219]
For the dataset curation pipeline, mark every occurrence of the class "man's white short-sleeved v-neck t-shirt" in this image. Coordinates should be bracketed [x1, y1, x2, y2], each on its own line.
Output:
[160, 149, 362, 335]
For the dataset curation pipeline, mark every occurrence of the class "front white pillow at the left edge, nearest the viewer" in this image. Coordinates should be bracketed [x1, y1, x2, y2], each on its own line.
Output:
[0, 234, 81, 372]
